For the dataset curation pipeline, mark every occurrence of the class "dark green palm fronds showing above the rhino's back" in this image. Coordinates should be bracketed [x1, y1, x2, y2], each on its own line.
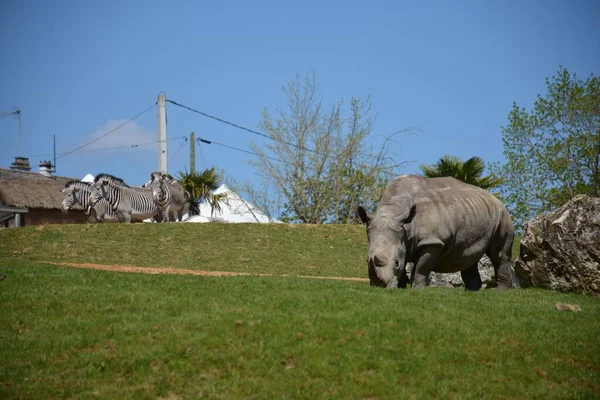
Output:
[420, 154, 503, 189]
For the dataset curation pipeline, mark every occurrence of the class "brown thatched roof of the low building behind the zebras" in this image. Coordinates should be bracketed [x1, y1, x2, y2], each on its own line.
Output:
[0, 168, 81, 210]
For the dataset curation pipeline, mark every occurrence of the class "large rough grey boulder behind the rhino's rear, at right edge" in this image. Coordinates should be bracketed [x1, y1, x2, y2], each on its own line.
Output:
[515, 195, 600, 296]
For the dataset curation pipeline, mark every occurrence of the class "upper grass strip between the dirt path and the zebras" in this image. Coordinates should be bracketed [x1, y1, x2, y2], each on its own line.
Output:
[0, 224, 367, 277]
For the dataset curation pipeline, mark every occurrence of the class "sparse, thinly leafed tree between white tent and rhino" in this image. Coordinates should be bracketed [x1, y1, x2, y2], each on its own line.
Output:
[252, 74, 408, 223]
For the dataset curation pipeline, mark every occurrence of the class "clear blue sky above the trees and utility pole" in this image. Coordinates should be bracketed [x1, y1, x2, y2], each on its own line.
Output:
[0, 0, 600, 189]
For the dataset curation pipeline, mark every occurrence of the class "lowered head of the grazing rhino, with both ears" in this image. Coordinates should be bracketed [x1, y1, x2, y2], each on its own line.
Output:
[356, 206, 415, 288]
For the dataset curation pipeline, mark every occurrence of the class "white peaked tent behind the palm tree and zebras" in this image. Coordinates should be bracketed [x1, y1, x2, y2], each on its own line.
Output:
[184, 184, 281, 223]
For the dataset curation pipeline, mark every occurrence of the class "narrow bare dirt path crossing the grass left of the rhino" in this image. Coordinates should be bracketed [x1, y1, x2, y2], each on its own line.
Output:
[41, 261, 369, 282]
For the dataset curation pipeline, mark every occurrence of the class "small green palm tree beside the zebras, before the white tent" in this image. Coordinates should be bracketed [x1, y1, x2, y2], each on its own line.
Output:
[178, 167, 227, 216]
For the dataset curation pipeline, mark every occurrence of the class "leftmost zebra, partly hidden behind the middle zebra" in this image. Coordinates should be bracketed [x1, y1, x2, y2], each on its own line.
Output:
[61, 180, 117, 223]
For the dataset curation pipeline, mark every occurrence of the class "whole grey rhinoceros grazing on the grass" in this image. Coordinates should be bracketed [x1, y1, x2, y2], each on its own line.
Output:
[356, 175, 514, 291]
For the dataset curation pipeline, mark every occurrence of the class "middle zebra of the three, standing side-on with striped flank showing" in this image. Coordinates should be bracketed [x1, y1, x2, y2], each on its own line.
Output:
[91, 174, 159, 223]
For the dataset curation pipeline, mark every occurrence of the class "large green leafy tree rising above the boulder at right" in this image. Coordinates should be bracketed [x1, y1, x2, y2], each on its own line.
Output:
[494, 67, 600, 226]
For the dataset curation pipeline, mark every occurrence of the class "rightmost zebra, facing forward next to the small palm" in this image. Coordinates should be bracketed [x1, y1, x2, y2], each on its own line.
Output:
[144, 172, 190, 222]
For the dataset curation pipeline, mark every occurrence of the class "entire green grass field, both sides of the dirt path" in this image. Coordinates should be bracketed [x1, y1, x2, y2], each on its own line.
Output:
[0, 224, 600, 399]
